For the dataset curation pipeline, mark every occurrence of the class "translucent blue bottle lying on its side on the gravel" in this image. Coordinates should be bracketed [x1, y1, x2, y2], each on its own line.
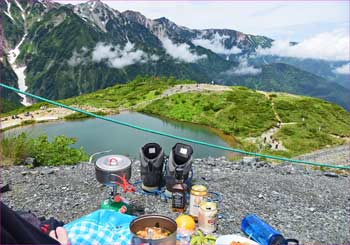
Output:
[241, 214, 299, 245]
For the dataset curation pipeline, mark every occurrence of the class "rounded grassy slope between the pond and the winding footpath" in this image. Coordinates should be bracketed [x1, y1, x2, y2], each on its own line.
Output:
[141, 87, 276, 137]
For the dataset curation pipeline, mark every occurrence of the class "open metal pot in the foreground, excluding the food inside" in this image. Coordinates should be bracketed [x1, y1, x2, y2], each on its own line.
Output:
[129, 215, 177, 245]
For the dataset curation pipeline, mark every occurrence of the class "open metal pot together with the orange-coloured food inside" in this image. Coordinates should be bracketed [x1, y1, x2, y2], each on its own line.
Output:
[129, 215, 177, 245]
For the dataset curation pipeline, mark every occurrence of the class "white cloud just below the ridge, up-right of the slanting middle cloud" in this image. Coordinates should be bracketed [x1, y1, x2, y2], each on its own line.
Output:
[192, 32, 242, 55]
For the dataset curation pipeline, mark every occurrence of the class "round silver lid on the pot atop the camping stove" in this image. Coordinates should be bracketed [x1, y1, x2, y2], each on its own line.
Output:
[96, 155, 131, 171]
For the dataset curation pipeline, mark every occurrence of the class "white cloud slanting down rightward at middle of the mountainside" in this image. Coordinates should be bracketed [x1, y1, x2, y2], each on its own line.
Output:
[160, 37, 207, 63]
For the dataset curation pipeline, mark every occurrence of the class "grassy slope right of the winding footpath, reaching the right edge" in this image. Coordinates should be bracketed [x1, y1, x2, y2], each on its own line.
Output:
[273, 95, 350, 153]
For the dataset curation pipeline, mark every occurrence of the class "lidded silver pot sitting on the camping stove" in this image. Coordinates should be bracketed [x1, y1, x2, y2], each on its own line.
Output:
[95, 155, 131, 186]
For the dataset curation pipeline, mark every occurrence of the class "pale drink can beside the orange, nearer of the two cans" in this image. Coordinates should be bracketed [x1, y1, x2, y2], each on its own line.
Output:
[198, 202, 218, 234]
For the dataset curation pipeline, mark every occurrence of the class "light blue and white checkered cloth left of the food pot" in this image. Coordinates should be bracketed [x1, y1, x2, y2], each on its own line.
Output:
[64, 209, 135, 245]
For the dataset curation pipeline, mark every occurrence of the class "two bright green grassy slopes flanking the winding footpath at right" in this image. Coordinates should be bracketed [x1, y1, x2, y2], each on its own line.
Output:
[141, 87, 350, 157]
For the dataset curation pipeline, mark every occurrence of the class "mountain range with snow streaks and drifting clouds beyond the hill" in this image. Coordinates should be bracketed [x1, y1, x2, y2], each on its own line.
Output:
[0, 0, 350, 109]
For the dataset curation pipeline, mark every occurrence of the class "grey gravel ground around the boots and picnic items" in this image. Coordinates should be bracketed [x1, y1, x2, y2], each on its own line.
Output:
[1, 158, 350, 244]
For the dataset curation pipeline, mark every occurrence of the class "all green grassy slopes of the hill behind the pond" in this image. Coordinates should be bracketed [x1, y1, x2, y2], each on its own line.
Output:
[2, 77, 350, 156]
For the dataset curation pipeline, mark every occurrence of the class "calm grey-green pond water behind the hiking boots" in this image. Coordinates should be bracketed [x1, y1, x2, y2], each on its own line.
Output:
[5, 112, 228, 158]
